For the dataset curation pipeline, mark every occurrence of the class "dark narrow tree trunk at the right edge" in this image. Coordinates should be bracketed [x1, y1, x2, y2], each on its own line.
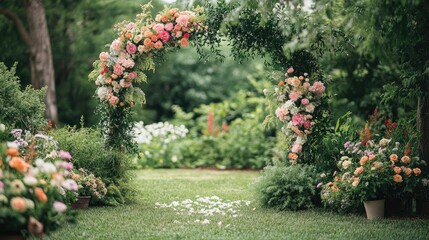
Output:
[417, 81, 429, 163]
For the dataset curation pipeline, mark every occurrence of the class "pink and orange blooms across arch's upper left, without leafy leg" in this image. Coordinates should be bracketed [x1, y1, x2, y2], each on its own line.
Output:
[95, 8, 207, 107]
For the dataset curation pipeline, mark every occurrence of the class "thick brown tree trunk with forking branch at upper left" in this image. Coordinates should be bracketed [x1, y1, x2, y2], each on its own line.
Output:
[0, 0, 58, 123]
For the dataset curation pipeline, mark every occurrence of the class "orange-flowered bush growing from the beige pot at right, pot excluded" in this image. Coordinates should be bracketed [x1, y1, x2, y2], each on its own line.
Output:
[321, 138, 424, 208]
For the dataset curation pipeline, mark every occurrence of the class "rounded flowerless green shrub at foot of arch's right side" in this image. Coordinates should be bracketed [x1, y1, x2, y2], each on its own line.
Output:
[255, 164, 318, 211]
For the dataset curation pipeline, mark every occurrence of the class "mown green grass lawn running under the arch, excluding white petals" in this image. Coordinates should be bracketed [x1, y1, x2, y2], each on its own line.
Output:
[44, 170, 429, 240]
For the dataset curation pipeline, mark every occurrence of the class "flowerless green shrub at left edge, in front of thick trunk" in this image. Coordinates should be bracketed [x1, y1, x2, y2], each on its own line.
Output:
[0, 62, 46, 132]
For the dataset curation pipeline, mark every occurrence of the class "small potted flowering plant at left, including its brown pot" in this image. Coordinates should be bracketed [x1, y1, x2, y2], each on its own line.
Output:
[72, 168, 107, 209]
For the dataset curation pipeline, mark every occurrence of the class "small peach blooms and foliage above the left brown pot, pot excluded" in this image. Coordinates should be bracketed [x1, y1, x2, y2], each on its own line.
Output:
[72, 168, 107, 200]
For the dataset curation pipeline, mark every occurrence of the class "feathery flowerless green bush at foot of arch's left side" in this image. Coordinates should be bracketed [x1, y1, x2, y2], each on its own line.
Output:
[49, 127, 133, 205]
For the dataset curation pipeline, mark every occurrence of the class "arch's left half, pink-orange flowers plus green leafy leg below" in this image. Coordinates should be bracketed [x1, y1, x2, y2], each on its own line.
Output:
[89, 3, 207, 151]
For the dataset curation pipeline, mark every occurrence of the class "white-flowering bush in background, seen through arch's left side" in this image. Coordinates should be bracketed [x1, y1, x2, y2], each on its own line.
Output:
[134, 122, 189, 167]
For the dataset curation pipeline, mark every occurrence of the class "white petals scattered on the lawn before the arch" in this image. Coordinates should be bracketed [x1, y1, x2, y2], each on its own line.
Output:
[155, 196, 251, 226]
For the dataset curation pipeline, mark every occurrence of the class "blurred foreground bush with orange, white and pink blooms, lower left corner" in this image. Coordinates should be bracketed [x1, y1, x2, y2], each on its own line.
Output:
[0, 143, 77, 236]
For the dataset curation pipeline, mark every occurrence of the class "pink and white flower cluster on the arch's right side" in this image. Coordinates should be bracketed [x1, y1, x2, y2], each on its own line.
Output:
[275, 68, 325, 161]
